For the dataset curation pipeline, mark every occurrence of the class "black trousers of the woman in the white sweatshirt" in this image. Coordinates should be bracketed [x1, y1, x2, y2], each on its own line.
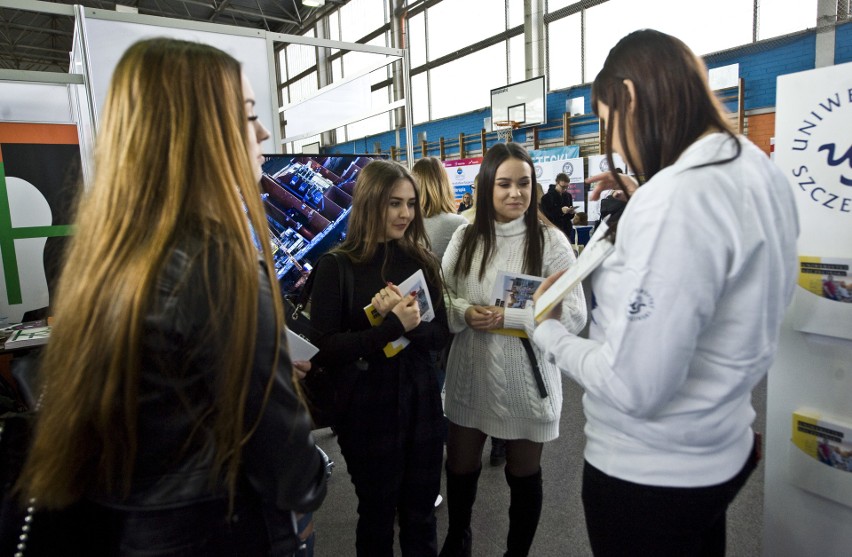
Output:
[583, 440, 759, 557]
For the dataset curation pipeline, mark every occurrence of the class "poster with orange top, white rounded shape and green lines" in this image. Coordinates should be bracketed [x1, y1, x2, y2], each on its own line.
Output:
[0, 123, 80, 325]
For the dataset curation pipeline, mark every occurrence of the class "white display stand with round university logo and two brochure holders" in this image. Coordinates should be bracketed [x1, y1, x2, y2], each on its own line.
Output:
[763, 60, 852, 557]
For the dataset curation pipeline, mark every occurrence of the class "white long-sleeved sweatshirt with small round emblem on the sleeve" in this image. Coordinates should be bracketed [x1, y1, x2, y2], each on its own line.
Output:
[534, 133, 799, 487]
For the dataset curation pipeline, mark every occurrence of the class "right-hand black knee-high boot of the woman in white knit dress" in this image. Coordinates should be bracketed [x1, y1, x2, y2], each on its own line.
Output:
[506, 468, 542, 557]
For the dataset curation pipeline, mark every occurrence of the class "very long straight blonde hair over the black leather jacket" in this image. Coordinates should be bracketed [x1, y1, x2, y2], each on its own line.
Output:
[19, 39, 283, 508]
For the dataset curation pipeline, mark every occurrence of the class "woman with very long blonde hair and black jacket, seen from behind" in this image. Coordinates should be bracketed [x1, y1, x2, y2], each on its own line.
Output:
[19, 39, 326, 556]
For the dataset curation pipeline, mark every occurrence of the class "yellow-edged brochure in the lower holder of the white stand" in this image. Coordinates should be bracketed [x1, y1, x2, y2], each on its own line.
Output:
[792, 409, 852, 472]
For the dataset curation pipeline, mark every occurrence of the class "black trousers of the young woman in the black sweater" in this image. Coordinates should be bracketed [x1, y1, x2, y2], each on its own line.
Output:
[336, 358, 443, 557]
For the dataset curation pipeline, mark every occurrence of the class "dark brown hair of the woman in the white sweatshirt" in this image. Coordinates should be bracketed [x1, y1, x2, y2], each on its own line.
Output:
[592, 29, 741, 238]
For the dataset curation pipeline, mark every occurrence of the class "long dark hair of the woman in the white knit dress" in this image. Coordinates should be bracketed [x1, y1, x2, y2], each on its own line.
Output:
[456, 143, 545, 279]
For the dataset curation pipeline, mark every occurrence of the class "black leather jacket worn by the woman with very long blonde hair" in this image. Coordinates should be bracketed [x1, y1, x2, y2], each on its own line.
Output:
[92, 238, 326, 556]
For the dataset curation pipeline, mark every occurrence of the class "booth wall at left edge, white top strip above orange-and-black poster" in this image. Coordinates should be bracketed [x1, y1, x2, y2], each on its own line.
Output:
[0, 70, 82, 325]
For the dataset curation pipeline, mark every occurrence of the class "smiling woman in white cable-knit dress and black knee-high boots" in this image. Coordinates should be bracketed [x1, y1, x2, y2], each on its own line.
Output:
[441, 143, 586, 557]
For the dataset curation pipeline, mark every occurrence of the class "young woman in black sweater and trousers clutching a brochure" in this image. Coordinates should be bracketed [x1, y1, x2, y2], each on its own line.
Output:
[311, 160, 449, 557]
